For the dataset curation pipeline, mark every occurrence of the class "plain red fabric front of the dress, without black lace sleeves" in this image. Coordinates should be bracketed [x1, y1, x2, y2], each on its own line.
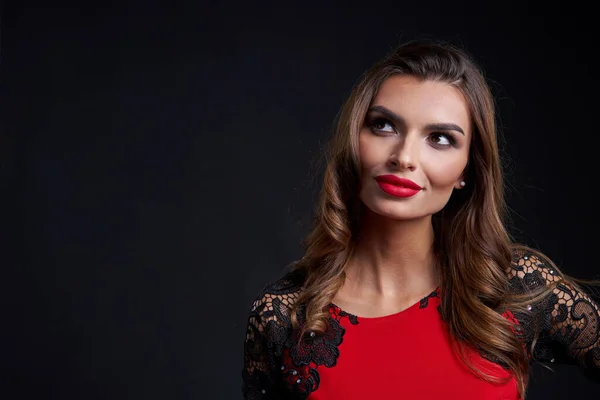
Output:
[308, 290, 519, 400]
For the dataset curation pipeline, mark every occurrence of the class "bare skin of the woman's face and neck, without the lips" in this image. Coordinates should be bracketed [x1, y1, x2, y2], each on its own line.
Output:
[333, 75, 472, 318]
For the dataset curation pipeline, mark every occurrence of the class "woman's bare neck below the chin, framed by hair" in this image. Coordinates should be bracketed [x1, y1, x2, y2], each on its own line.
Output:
[344, 207, 439, 299]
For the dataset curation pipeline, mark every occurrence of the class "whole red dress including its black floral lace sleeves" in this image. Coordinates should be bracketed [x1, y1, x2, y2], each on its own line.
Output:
[242, 250, 600, 400]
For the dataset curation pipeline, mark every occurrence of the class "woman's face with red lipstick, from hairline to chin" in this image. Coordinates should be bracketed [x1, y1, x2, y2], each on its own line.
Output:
[359, 75, 471, 220]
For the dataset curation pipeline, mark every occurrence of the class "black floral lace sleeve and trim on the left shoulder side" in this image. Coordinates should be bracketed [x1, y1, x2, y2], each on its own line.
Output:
[242, 273, 358, 399]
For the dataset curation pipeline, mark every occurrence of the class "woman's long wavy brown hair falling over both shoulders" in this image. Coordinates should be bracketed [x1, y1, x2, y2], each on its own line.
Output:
[291, 40, 596, 398]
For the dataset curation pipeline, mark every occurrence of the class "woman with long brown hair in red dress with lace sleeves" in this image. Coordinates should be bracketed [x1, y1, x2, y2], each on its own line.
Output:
[243, 41, 600, 400]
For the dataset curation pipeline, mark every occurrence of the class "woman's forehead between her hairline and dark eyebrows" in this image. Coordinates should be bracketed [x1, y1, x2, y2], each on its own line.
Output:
[371, 75, 471, 133]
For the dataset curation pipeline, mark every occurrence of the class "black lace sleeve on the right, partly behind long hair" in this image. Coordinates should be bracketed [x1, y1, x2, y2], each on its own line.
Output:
[509, 249, 600, 382]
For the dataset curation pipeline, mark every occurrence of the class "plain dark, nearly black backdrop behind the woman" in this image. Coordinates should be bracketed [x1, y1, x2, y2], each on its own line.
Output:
[0, 1, 600, 400]
